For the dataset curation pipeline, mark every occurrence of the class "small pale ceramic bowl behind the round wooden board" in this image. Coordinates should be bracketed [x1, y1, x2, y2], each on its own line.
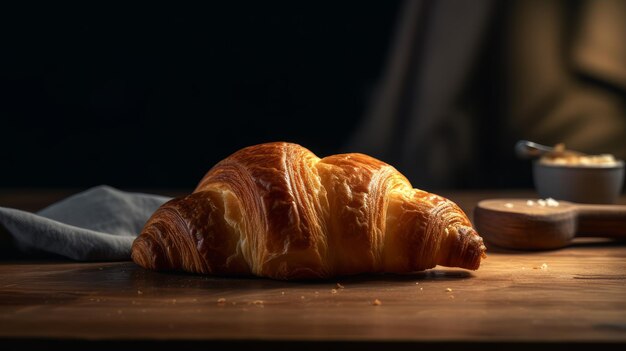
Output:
[533, 160, 624, 204]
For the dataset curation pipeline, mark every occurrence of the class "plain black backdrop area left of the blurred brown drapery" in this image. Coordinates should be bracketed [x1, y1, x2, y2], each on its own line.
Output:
[0, 1, 399, 188]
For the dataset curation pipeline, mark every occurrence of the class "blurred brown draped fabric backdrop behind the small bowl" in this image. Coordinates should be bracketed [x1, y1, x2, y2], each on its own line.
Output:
[347, 0, 626, 189]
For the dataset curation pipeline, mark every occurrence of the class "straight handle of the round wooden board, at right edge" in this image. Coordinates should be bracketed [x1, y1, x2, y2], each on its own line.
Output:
[576, 205, 626, 238]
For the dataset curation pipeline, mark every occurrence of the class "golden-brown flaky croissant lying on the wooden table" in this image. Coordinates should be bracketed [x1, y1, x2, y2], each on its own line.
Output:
[132, 142, 485, 279]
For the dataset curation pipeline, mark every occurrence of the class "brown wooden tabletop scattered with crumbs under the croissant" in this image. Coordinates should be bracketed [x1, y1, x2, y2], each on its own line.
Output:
[0, 192, 626, 350]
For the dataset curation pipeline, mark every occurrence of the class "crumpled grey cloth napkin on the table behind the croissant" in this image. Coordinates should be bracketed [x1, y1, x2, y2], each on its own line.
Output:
[0, 185, 169, 261]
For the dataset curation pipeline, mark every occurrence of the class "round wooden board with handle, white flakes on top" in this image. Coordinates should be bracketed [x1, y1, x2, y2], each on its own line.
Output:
[474, 199, 626, 250]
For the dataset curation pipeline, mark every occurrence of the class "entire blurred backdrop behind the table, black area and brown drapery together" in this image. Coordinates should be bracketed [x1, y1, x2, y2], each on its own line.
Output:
[0, 0, 626, 190]
